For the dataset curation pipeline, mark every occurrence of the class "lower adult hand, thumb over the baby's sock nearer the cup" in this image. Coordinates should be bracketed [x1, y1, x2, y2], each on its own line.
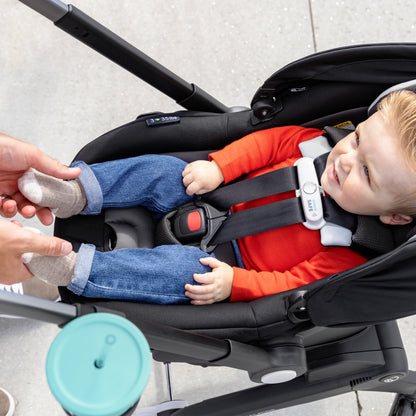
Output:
[0, 219, 72, 285]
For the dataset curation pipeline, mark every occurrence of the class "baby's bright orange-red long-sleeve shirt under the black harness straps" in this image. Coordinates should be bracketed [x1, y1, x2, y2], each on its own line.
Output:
[210, 126, 366, 302]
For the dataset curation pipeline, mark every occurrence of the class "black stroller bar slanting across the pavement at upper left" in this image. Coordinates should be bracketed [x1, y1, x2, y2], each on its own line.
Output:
[19, 0, 231, 113]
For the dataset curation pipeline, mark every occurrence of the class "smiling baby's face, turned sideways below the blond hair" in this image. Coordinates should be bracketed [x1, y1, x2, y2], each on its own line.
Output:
[321, 112, 415, 216]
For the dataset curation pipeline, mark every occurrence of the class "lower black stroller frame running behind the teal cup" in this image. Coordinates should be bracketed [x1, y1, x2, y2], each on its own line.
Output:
[0, 292, 416, 416]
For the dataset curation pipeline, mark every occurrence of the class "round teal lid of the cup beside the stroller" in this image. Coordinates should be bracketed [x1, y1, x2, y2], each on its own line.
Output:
[46, 313, 151, 416]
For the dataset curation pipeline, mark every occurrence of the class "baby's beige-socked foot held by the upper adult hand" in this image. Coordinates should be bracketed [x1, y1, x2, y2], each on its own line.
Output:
[18, 171, 87, 218]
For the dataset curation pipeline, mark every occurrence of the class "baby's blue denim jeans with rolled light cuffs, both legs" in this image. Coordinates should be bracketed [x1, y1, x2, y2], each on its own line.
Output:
[68, 155, 216, 304]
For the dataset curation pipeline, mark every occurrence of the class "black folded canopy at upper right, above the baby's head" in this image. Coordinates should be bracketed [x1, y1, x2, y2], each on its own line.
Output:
[251, 43, 415, 124]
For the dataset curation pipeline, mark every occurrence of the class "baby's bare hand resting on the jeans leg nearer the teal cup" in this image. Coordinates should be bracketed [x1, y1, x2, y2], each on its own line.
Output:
[185, 257, 234, 305]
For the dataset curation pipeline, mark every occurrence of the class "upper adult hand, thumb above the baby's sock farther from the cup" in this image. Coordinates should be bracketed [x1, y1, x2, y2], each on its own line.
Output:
[0, 133, 80, 225]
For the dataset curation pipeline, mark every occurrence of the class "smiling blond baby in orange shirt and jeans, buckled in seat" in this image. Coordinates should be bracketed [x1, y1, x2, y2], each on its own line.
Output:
[19, 91, 416, 305]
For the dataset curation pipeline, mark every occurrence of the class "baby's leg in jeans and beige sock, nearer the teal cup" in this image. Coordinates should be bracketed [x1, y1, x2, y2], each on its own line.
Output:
[26, 244, 211, 304]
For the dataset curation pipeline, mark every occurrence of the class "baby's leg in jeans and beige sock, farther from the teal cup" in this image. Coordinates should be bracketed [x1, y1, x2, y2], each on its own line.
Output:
[19, 155, 192, 218]
